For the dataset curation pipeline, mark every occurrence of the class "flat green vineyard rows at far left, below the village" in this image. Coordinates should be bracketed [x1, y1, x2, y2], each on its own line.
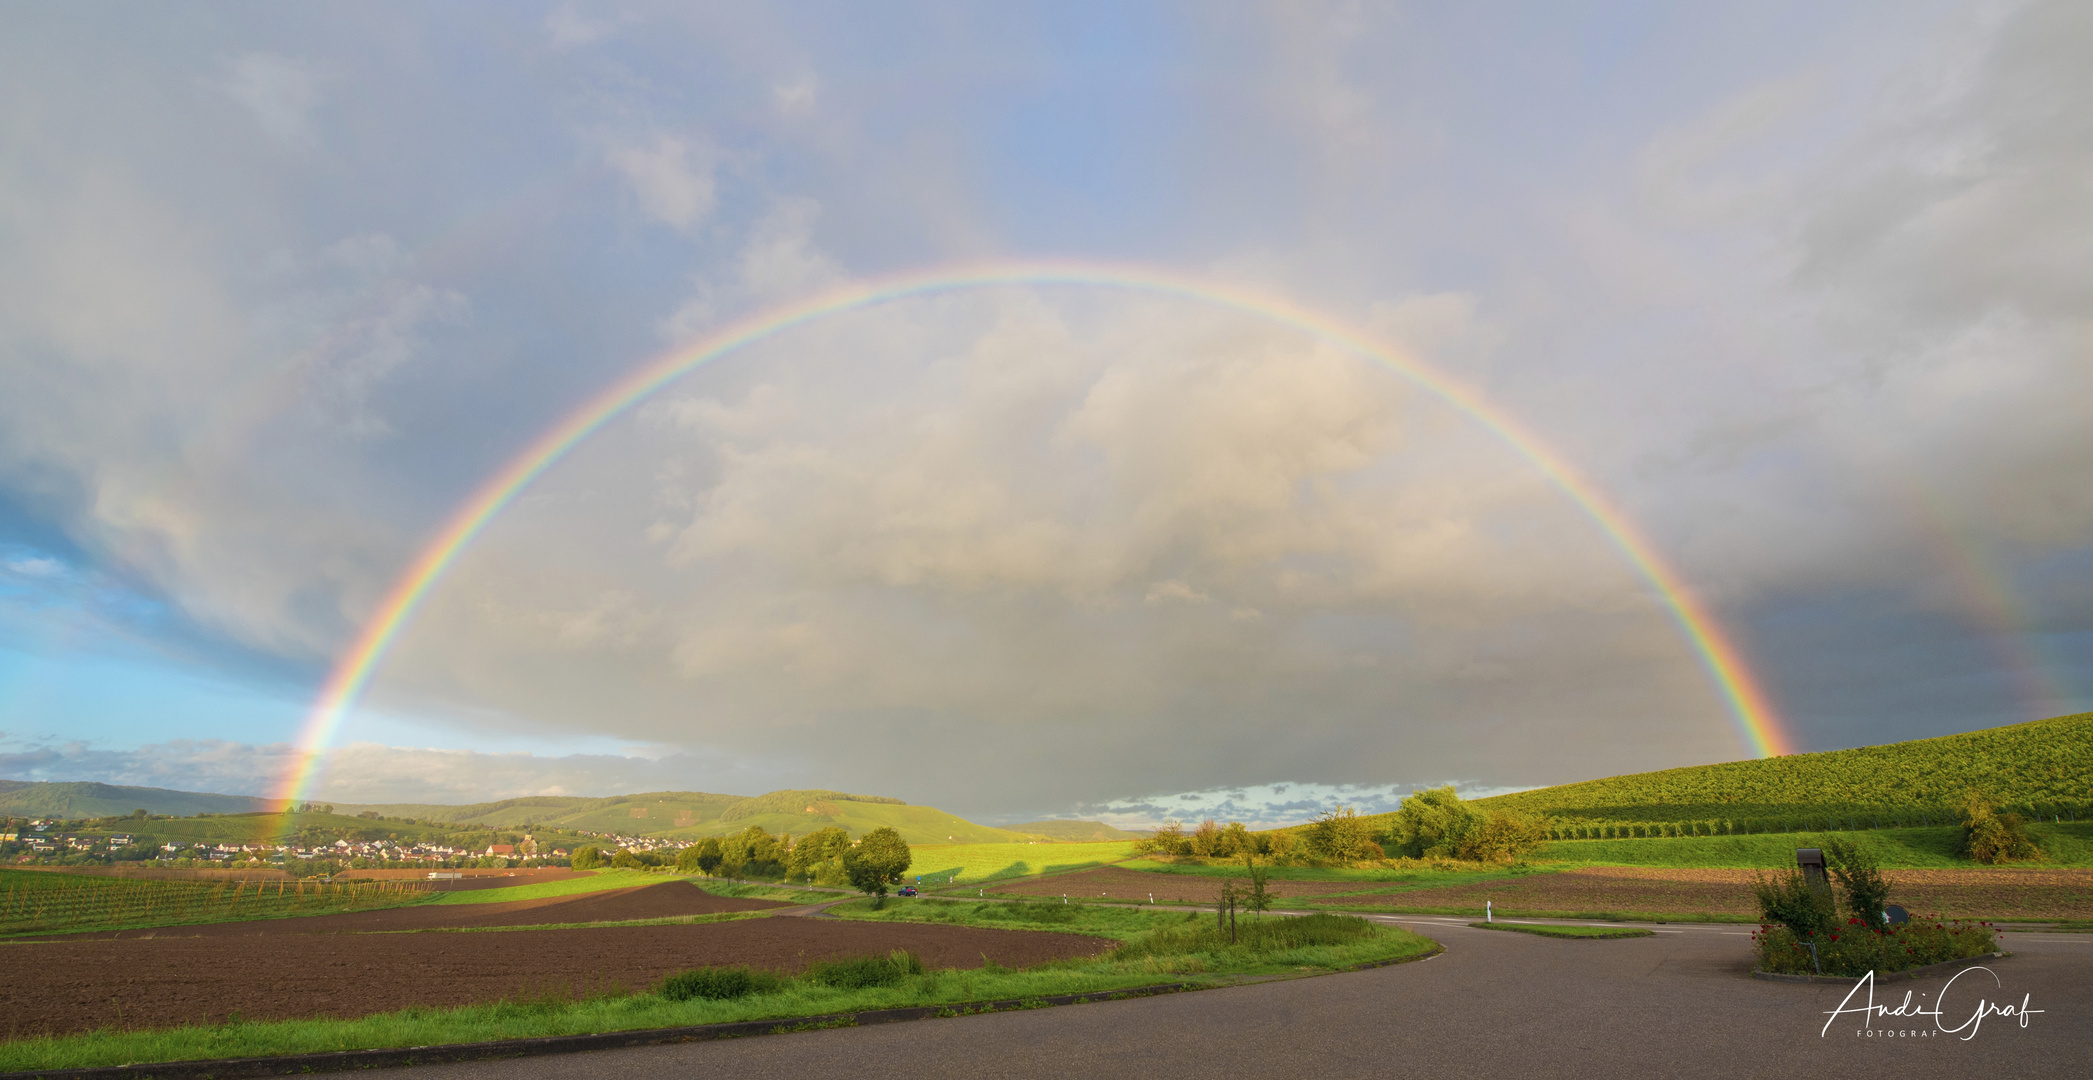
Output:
[0, 871, 431, 936]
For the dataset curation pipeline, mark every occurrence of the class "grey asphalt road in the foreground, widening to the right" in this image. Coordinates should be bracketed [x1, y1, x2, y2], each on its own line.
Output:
[412, 917, 2093, 1080]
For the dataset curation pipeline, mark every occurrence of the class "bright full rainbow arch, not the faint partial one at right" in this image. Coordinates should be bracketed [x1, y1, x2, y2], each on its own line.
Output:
[276, 262, 1794, 820]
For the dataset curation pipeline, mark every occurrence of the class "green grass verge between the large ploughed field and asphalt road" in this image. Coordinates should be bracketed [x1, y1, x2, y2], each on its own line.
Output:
[0, 900, 1436, 1072]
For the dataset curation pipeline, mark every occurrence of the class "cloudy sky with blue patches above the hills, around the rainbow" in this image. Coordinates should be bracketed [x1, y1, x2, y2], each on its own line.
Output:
[0, 2, 2093, 825]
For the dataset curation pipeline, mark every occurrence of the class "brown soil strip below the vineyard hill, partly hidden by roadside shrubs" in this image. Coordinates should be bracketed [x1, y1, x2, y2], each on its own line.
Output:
[1312, 867, 2093, 919]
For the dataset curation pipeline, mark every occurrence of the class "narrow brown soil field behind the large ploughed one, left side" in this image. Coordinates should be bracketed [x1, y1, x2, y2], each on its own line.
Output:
[44, 881, 793, 942]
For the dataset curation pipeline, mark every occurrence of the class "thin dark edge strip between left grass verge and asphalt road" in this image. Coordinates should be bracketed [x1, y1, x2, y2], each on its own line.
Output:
[0, 987, 1205, 1080]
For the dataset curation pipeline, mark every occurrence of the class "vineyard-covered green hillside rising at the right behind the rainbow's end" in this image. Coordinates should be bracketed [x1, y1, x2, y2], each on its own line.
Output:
[1478, 712, 2093, 829]
